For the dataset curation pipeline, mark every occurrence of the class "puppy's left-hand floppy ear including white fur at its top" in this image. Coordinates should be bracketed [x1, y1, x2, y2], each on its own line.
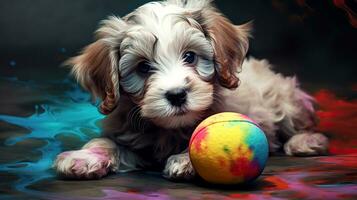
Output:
[65, 17, 124, 114]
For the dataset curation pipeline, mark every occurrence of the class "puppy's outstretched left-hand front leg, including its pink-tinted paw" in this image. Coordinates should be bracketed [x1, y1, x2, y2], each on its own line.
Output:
[53, 138, 119, 179]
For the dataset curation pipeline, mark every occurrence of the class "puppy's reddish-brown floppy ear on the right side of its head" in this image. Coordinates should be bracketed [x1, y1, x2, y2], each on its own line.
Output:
[200, 7, 251, 89]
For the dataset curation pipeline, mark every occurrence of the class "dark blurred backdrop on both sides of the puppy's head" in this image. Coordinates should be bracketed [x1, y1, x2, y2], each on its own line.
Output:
[0, 0, 357, 91]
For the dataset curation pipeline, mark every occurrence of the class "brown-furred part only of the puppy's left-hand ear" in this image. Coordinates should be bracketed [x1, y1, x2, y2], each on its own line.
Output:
[66, 40, 119, 114]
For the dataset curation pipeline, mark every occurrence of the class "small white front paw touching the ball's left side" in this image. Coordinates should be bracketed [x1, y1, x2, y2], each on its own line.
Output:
[163, 153, 196, 180]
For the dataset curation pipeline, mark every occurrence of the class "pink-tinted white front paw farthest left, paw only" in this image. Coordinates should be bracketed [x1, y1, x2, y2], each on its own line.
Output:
[53, 148, 114, 179]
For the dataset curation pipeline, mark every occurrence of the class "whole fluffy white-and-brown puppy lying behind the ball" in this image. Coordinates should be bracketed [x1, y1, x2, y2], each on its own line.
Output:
[54, 0, 328, 179]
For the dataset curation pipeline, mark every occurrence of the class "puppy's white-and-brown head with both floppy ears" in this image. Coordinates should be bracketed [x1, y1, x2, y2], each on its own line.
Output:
[69, 0, 249, 128]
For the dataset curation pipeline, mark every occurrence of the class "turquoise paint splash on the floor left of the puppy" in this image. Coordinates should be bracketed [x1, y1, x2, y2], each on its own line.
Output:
[0, 79, 103, 197]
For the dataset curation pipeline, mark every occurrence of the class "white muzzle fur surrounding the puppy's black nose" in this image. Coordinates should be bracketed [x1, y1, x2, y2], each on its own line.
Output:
[141, 65, 213, 128]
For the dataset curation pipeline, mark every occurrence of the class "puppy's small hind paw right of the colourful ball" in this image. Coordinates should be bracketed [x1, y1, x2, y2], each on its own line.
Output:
[284, 133, 328, 156]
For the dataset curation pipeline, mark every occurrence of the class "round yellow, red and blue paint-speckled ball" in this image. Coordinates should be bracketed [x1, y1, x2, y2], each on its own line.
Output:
[189, 112, 269, 184]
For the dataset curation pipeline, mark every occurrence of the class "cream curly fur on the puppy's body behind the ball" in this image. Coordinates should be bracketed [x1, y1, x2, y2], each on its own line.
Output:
[216, 58, 312, 151]
